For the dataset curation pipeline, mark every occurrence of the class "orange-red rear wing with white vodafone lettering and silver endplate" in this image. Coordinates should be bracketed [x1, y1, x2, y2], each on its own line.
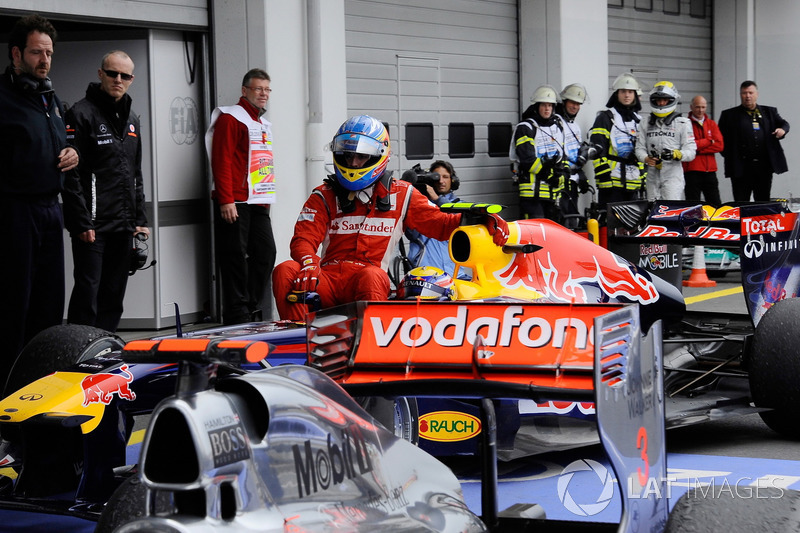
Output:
[308, 302, 668, 531]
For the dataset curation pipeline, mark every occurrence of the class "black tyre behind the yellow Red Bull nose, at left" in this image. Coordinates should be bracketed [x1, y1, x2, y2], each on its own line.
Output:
[3, 324, 125, 398]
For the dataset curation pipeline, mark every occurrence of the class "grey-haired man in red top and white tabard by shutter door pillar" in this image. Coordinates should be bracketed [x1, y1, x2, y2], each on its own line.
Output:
[206, 68, 276, 324]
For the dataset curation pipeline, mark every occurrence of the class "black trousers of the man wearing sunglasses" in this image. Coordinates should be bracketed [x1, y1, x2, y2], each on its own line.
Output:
[67, 231, 133, 332]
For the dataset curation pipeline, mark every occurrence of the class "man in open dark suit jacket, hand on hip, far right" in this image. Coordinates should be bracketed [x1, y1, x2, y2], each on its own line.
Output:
[719, 80, 789, 202]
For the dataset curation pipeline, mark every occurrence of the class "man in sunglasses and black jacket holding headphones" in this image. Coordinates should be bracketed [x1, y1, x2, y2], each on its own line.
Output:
[62, 50, 150, 332]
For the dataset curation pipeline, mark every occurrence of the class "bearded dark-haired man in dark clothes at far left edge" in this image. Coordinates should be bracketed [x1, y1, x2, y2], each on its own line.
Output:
[0, 15, 78, 388]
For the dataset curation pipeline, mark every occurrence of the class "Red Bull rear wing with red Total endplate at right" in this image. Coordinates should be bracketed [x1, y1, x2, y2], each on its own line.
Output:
[608, 200, 800, 324]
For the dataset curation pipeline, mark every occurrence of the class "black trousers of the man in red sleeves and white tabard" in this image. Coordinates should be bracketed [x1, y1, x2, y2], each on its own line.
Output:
[214, 202, 276, 324]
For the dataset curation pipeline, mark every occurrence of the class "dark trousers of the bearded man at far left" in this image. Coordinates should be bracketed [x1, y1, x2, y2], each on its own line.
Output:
[0, 195, 64, 387]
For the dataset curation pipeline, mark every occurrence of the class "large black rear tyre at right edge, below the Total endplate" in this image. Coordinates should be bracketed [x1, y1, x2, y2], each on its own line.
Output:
[748, 298, 800, 440]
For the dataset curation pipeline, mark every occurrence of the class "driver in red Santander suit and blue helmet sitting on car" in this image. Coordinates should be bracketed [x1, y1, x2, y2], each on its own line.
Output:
[272, 115, 508, 321]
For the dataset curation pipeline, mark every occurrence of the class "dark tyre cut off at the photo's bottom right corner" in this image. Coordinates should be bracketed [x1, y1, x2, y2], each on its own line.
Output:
[664, 485, 800, 533]
